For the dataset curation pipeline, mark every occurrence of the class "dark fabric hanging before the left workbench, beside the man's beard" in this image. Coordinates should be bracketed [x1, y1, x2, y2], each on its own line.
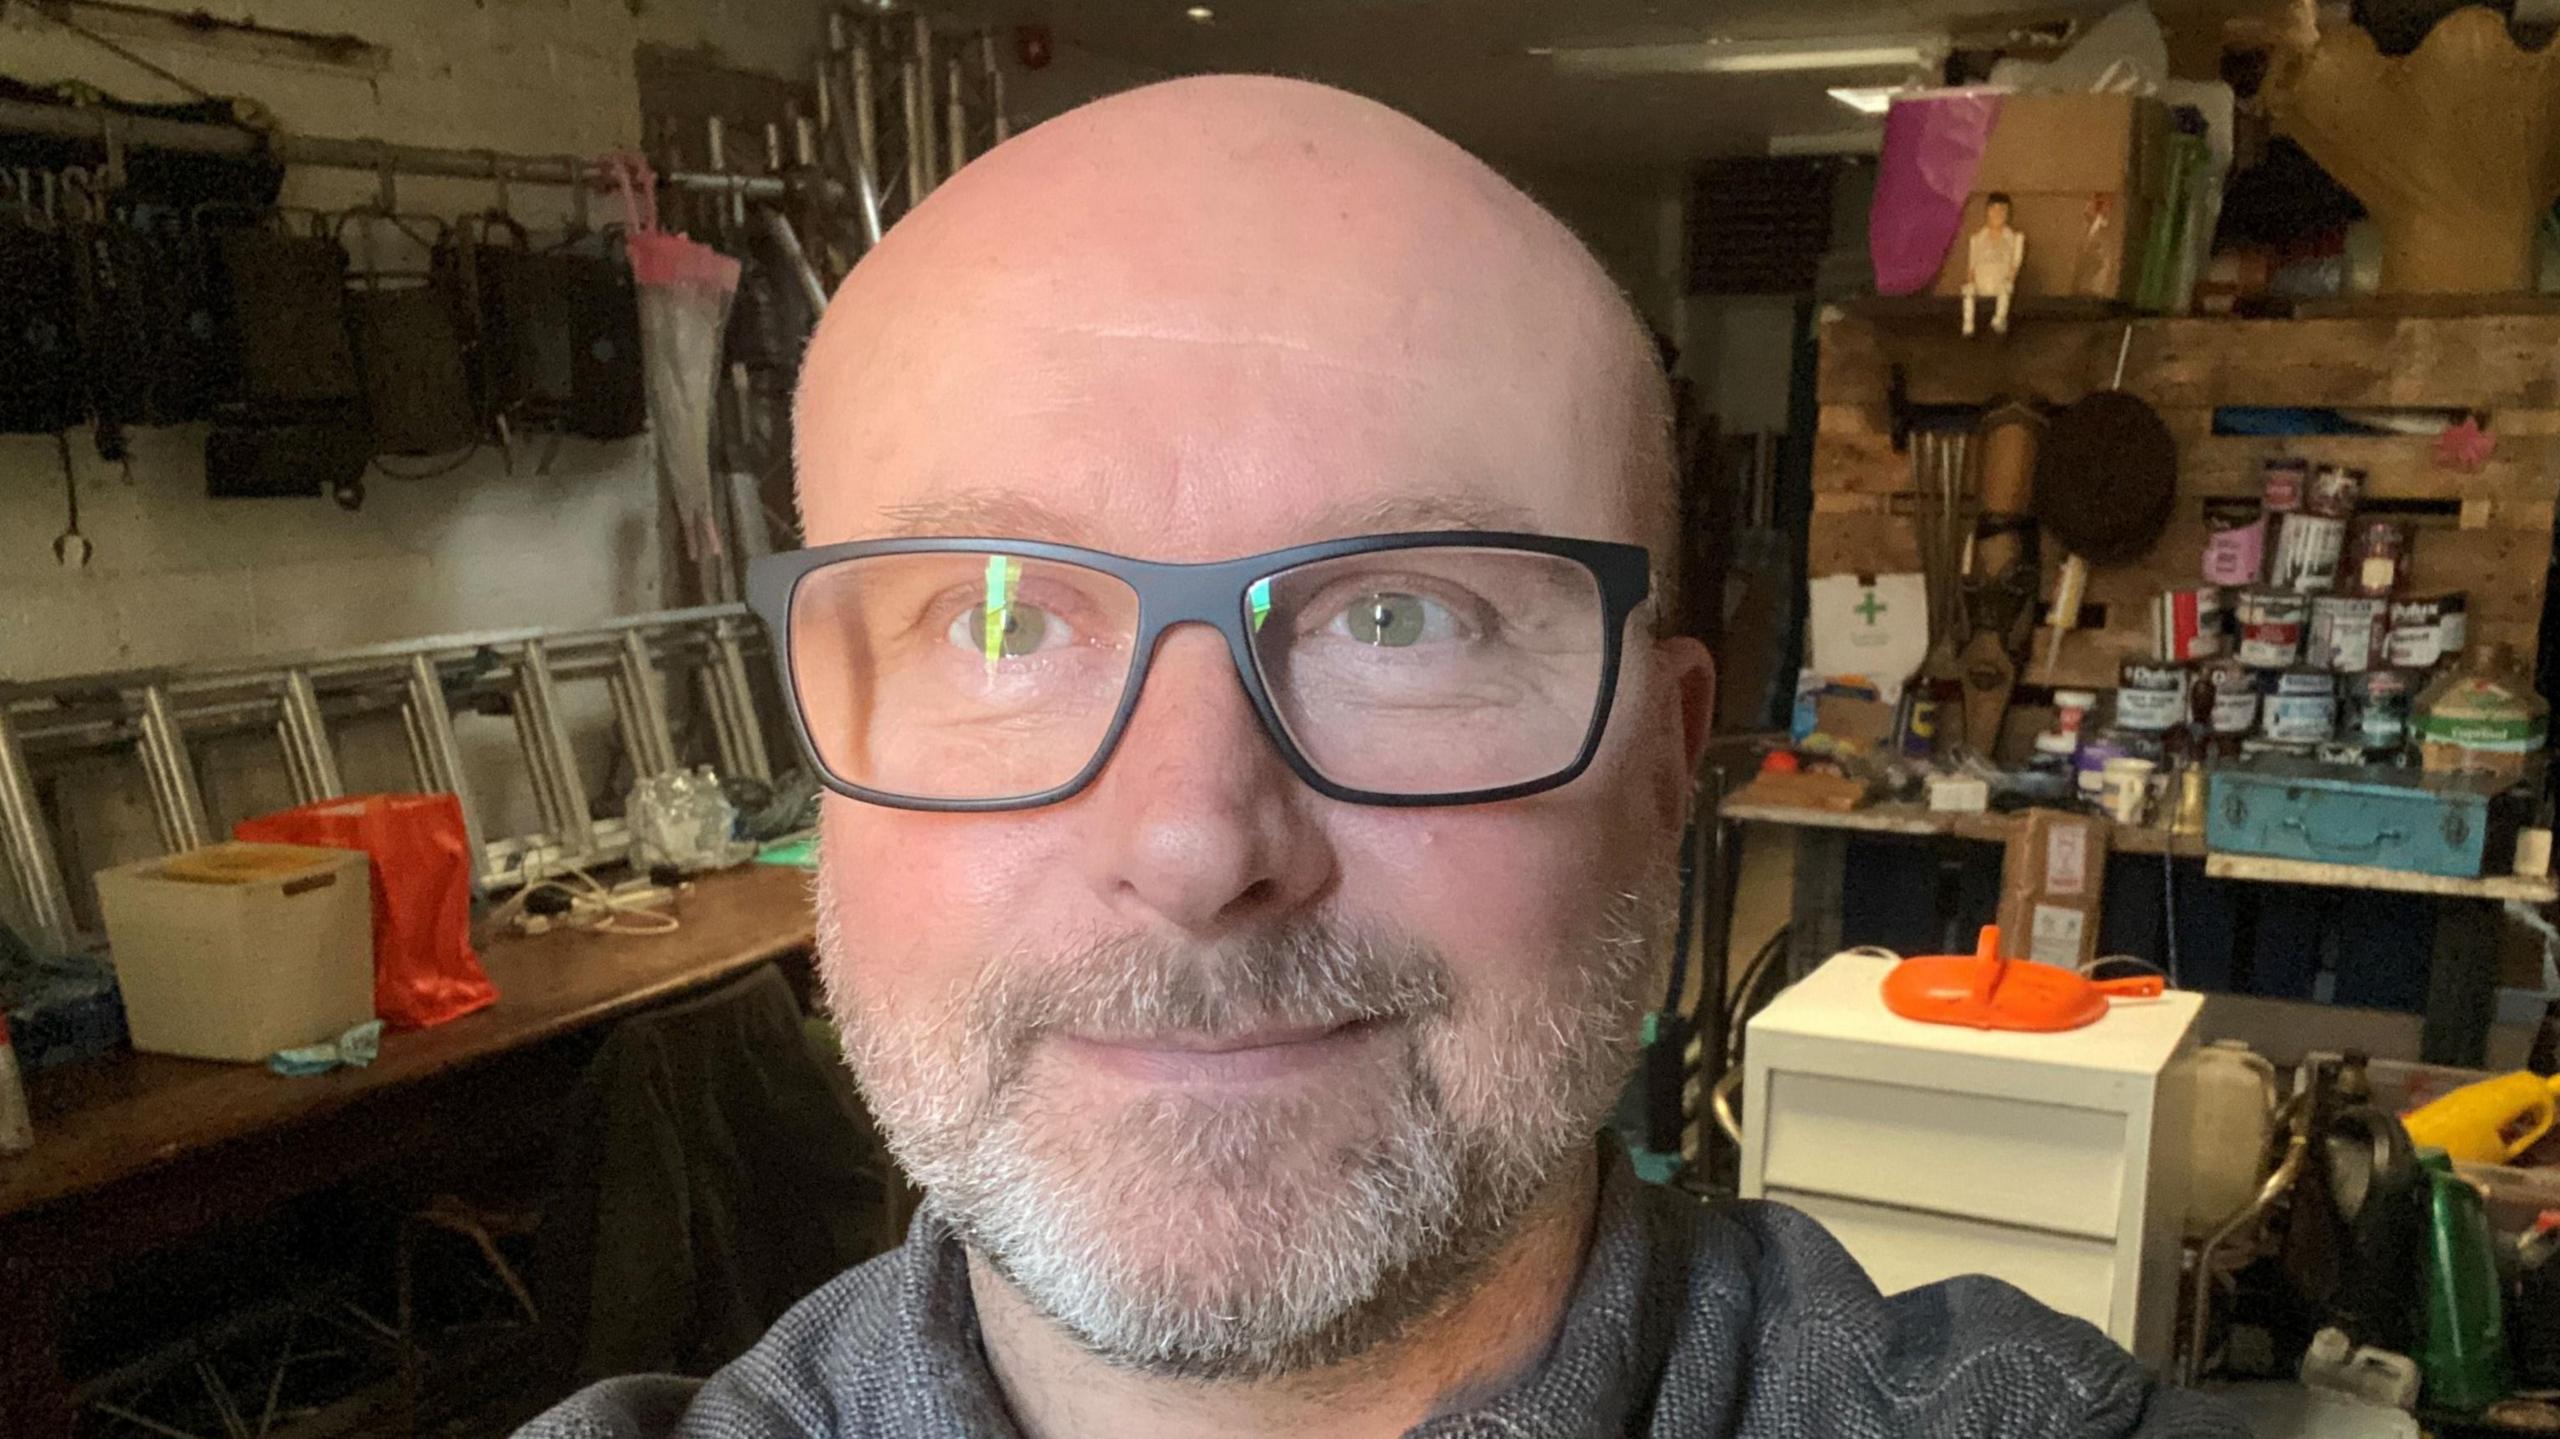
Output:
[540, 965, 878, 1380]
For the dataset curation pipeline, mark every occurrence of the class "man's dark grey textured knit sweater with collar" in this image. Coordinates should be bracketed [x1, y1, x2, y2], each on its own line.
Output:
[520, 1155, 2248, 1439]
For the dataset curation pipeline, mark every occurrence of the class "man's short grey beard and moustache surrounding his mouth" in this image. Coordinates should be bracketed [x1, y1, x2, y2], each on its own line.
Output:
[819, 863, 1677, 1380]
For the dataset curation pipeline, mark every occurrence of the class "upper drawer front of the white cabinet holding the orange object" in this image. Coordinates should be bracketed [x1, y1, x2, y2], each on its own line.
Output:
[1761, 1070, 2148, 1242]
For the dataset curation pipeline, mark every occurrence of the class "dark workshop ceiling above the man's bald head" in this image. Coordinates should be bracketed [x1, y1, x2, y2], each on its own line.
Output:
[952, 0, 2109, 172]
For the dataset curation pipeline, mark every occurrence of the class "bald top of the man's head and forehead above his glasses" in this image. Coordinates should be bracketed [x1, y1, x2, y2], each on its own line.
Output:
[799, 77, 1672, 583]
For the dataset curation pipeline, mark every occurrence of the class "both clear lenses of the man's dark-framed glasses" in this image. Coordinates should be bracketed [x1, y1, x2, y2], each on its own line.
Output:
[788, 545, 1608, 801]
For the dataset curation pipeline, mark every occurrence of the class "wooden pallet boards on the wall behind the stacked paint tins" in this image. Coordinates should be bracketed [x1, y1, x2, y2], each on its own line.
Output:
[1810, 307, 2560, 686]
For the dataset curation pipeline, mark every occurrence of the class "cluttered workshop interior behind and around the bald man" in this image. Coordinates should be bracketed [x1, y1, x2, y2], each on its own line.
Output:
[0, 0, 2560, 1439]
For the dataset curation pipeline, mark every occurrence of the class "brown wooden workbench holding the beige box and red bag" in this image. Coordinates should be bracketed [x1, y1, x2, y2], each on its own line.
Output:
[0, 865, 814, 1436]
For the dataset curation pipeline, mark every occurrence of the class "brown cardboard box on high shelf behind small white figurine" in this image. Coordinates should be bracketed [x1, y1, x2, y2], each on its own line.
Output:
[1930, 95, 2168, 300]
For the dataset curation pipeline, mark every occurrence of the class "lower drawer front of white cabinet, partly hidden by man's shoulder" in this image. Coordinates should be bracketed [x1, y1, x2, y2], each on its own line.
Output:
[1766, 1186, 2132, 1344]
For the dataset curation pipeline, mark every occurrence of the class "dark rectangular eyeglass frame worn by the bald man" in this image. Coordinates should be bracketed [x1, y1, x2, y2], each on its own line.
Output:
[748, 530, 1651, 812]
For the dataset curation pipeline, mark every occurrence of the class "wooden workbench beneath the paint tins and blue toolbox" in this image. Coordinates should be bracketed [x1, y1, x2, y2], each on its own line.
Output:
[1718, 801, 2560, 1065]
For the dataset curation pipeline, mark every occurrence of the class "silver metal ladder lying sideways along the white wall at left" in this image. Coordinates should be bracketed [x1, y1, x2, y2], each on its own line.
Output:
[0, 604, 773, 950]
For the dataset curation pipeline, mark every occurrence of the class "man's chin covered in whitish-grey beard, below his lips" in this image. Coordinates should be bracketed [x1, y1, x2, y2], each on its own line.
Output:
[945, 1034, 1510, 1380]
